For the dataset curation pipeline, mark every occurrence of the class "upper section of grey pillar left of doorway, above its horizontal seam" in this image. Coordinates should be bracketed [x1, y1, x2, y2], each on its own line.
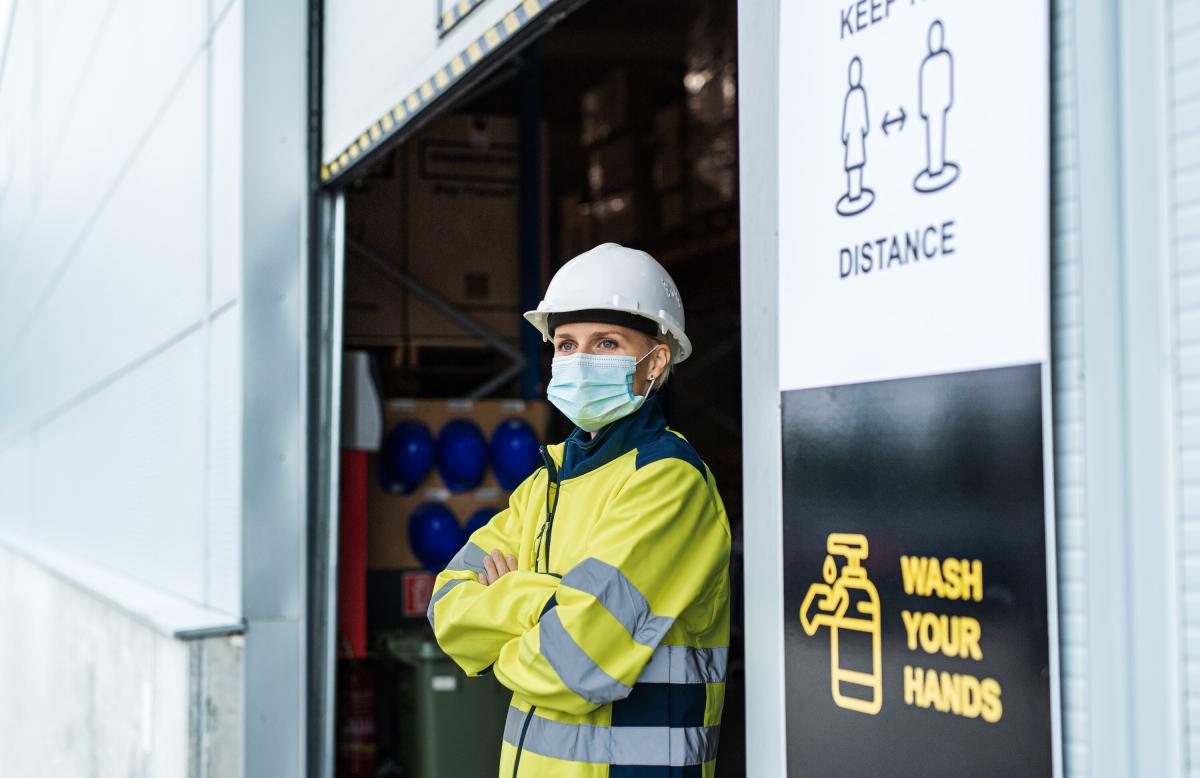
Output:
[242, 0, 307, 618]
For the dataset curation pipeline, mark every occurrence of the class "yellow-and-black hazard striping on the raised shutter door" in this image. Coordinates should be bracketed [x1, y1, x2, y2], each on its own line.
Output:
[320, 0, 554, 182]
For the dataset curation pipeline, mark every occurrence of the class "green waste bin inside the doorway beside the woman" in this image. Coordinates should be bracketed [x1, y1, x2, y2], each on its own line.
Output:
[378, 630, 511, 778]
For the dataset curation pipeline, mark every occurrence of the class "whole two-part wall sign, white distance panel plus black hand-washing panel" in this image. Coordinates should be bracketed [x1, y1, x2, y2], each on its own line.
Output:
[779, 0, 1057, 776]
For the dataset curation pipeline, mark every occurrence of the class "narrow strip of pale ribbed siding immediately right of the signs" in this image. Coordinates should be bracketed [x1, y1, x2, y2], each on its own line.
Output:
[1051, 0, 1088, 776]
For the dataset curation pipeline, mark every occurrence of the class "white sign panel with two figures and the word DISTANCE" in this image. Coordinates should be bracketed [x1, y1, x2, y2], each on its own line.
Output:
[779, 0, 1050, 390]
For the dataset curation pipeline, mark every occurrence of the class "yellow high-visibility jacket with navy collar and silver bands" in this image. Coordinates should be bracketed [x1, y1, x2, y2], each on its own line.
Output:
[428, 397, 730, 778]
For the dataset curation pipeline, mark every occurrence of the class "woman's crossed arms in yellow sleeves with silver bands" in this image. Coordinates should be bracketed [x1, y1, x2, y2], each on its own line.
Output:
[430, 462, 730, 714]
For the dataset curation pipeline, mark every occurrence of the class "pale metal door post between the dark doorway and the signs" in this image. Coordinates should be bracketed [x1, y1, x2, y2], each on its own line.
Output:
[738, 0, 788, 776]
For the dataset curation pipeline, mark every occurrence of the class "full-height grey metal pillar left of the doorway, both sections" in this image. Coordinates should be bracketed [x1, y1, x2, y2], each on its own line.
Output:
[240, 0, 309, 776]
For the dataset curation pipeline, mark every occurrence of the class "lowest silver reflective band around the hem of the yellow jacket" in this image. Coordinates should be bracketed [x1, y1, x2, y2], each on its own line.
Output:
[504, 707, 721, 767]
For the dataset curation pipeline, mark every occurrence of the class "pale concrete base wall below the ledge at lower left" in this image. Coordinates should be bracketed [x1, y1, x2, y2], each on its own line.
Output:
[0, 546, 243, 778]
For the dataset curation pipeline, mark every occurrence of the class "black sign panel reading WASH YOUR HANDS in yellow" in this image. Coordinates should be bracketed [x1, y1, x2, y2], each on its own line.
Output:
[782, 365, 1052, 776]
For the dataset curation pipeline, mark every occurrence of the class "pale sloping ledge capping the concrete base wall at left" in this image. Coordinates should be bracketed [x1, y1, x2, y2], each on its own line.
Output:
[0, 528, 246, 640]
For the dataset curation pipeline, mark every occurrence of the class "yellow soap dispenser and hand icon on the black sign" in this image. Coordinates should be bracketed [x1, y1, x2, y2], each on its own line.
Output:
[800, 532, 883, 716]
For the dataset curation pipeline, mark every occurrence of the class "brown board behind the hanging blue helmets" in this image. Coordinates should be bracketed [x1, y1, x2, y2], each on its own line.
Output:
[367, 400, 550, 569]
